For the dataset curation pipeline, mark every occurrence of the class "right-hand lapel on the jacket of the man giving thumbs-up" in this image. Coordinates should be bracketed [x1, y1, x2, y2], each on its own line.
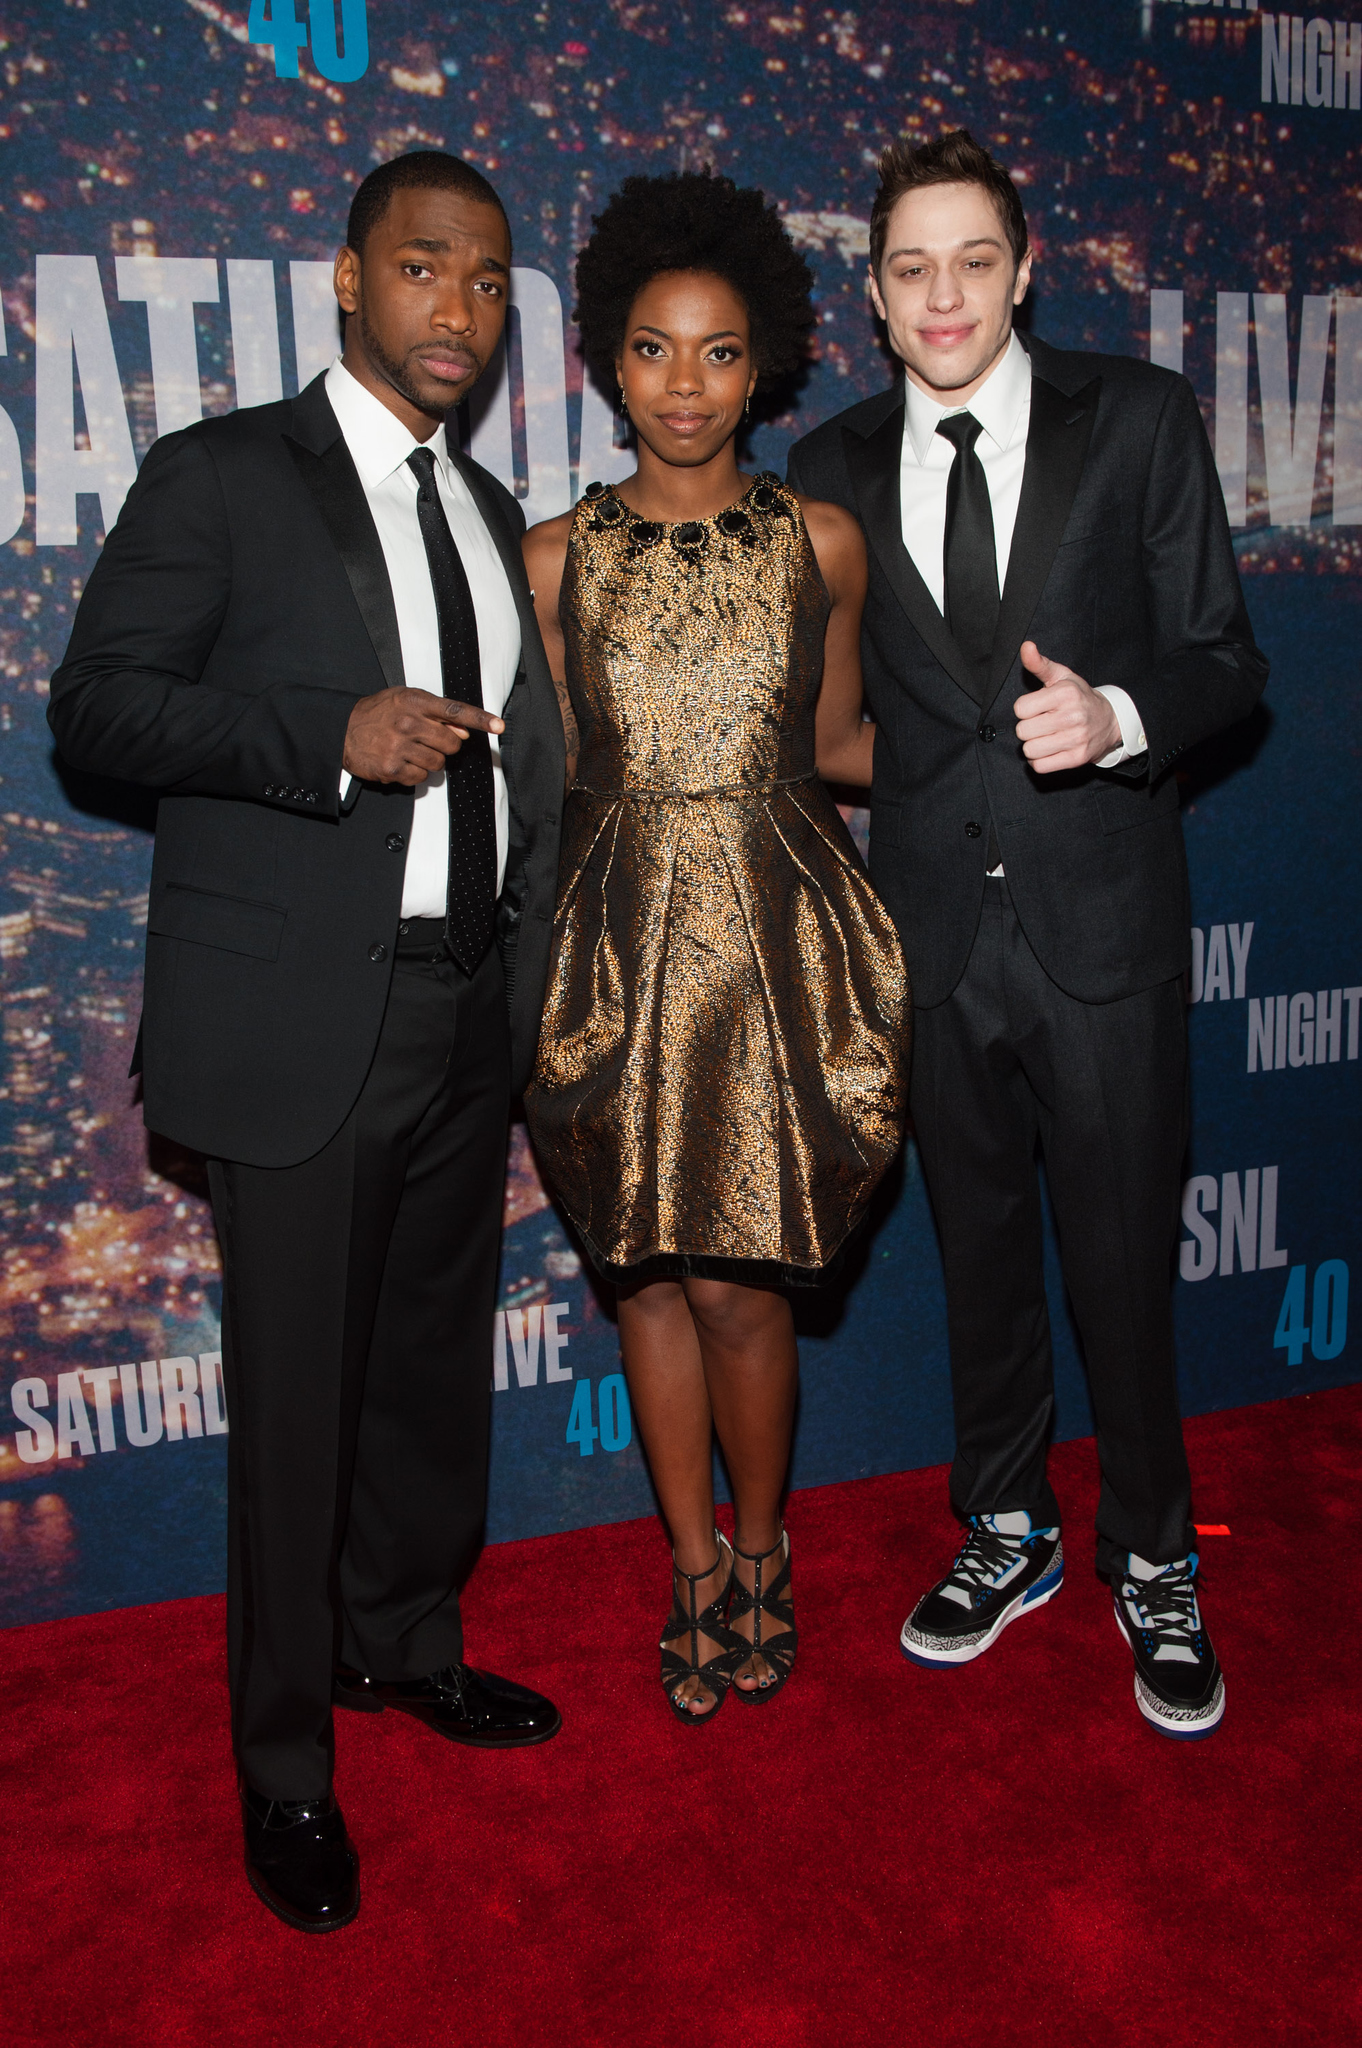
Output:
[985, 377, 1102, 705]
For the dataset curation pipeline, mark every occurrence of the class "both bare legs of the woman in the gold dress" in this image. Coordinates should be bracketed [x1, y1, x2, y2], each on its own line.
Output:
[619, 1280, 799, 1714]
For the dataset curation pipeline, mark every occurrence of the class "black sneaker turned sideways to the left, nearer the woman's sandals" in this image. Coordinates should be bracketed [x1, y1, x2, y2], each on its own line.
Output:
[899, 1507, 1065, 1665]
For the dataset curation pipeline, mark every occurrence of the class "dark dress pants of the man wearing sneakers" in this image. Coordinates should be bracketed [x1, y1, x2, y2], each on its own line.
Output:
[911, 879, 1194, 1573]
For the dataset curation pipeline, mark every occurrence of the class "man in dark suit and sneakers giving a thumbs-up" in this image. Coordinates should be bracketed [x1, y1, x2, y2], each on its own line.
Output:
[789, 131, 1268, 1739]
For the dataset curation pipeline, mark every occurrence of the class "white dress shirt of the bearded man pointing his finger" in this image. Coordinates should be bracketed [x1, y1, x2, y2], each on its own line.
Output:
[326, 356, 520, 918]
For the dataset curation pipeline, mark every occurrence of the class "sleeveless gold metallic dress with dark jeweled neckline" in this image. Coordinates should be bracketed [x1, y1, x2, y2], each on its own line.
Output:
[524, 477, 909, 1286]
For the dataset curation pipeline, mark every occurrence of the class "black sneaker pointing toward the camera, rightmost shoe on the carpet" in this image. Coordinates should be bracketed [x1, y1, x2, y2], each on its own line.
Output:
[1112, 1550, 1225, 1743]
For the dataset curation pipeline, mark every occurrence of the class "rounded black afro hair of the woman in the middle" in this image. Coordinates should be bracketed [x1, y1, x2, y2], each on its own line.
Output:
[573, 170, 813, 389]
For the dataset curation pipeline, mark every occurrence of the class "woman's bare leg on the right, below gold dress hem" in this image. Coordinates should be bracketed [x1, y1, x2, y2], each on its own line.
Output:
[682, 1280, 799, 1692]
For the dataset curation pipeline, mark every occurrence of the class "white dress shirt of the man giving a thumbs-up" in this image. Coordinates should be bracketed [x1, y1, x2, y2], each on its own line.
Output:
[899, 334, 1147, 768]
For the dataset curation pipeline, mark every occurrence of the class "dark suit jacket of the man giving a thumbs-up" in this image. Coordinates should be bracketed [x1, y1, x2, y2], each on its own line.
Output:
[789, 340, 1268, 1008]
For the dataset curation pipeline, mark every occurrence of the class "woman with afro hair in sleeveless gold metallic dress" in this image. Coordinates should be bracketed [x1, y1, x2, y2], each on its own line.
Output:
[524, 174, 909, 1724]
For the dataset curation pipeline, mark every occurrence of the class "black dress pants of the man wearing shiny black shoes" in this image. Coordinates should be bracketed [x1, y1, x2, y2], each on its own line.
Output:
[209, 942, 510, 1798]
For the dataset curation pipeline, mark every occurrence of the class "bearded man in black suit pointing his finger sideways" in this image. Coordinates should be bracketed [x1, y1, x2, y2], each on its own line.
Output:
[49, 152, 563, 1929]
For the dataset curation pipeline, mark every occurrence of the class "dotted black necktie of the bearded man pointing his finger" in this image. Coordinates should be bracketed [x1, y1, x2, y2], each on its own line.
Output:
[408, 449, 496, 975]
